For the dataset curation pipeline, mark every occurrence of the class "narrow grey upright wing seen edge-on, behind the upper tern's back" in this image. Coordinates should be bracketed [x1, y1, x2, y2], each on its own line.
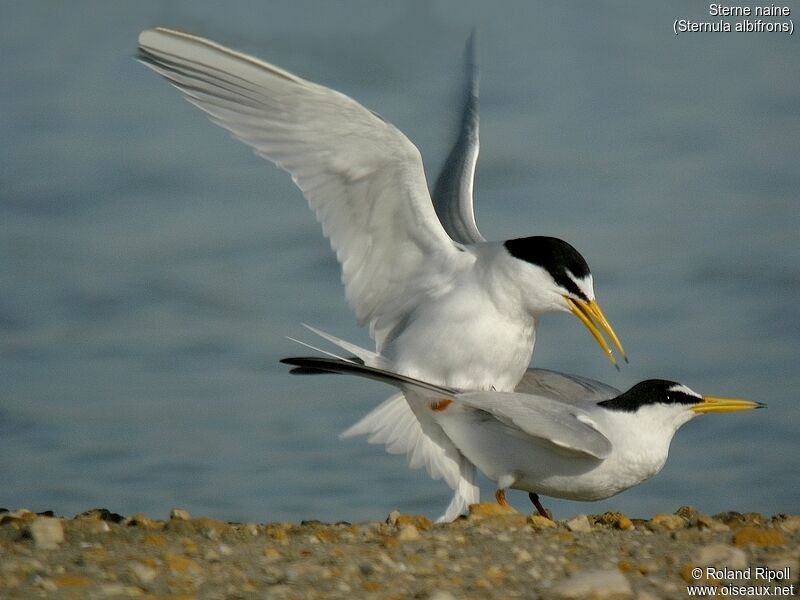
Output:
[433, 31, 485, 244]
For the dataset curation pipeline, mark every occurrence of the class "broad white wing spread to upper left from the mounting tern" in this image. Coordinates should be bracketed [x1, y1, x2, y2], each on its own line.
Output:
[139, 28, 472, 348]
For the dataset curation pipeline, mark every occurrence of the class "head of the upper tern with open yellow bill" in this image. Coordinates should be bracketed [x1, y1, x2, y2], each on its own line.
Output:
[503, 236, 628, 366]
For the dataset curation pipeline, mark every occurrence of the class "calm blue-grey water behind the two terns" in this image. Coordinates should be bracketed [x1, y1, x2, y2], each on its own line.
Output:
[0, 0, 800, 521]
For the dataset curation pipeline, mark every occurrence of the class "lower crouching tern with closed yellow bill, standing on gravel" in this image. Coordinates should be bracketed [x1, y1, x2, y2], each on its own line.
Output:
[281, 357, 765, 517]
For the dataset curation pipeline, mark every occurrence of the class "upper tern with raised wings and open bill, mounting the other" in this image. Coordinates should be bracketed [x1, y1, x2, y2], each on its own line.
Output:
[139, 28, 625, 520]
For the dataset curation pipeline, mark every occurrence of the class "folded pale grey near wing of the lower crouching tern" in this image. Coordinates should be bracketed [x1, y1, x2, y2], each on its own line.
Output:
[458, 392, 611, 459]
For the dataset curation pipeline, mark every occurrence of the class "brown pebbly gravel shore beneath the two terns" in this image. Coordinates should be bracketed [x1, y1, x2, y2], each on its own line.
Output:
[0, 503, 800, 600]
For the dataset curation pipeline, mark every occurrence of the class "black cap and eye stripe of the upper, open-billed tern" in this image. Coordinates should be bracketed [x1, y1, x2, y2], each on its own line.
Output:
[503, 236, 591, 302]
